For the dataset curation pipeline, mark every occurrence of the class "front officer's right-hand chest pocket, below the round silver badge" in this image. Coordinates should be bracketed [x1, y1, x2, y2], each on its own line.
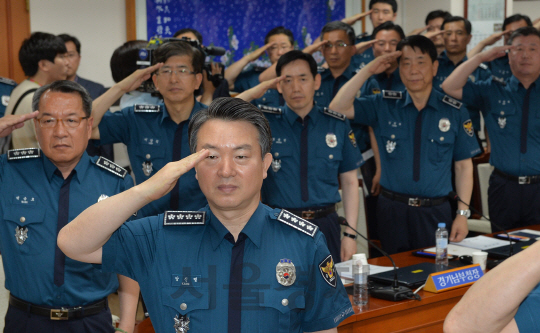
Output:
[259, 287, 306, 333]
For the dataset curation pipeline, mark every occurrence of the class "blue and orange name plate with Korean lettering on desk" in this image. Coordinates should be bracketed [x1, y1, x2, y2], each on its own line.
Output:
[424, 264, 484, 293]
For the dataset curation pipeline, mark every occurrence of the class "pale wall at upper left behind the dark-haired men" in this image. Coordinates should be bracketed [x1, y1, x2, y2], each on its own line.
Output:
[30, 0, 126, 86]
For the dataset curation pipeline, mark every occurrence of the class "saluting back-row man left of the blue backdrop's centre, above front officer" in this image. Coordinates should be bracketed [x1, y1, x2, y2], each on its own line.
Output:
[225, 26, 294, 106]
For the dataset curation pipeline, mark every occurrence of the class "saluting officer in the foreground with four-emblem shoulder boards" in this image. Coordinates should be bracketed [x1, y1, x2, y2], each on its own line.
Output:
[58, 98, 353, 333]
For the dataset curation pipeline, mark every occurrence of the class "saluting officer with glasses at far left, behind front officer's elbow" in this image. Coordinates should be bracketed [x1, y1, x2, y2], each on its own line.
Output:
[0, 81, 138, 333]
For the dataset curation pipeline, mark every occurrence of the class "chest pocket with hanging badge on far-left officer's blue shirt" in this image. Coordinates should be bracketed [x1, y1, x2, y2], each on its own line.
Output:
[4, 205, 45, 255]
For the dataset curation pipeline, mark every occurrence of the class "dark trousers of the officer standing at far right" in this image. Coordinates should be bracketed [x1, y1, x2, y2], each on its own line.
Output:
[488, 172, 540, 232]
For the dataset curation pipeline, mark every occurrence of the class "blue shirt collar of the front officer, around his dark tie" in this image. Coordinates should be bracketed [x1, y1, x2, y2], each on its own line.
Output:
[205, 202, 266, 251]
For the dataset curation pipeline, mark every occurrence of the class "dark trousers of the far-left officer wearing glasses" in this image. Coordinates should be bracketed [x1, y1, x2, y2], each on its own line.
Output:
[4, 306, 114, 333]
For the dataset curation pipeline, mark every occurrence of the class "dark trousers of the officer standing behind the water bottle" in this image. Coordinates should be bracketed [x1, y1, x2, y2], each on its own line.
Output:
[377, 195, 453, 254]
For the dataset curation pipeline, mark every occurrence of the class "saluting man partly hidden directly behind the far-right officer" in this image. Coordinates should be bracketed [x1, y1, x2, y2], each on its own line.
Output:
[467, 14, 533, 80]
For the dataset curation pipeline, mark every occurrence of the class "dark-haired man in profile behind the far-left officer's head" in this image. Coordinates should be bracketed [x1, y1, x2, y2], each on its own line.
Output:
[58, 34, 107, 99]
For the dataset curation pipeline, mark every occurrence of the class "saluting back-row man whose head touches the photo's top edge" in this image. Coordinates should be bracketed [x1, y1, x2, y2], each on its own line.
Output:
[342, 0, 398, 68]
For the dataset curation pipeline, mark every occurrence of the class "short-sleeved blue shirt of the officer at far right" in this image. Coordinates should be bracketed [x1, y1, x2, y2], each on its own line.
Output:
[463, 75, 540, 176]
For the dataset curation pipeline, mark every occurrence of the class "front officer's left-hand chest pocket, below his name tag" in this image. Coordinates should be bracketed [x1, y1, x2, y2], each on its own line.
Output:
[162, 287, 209, 332]
